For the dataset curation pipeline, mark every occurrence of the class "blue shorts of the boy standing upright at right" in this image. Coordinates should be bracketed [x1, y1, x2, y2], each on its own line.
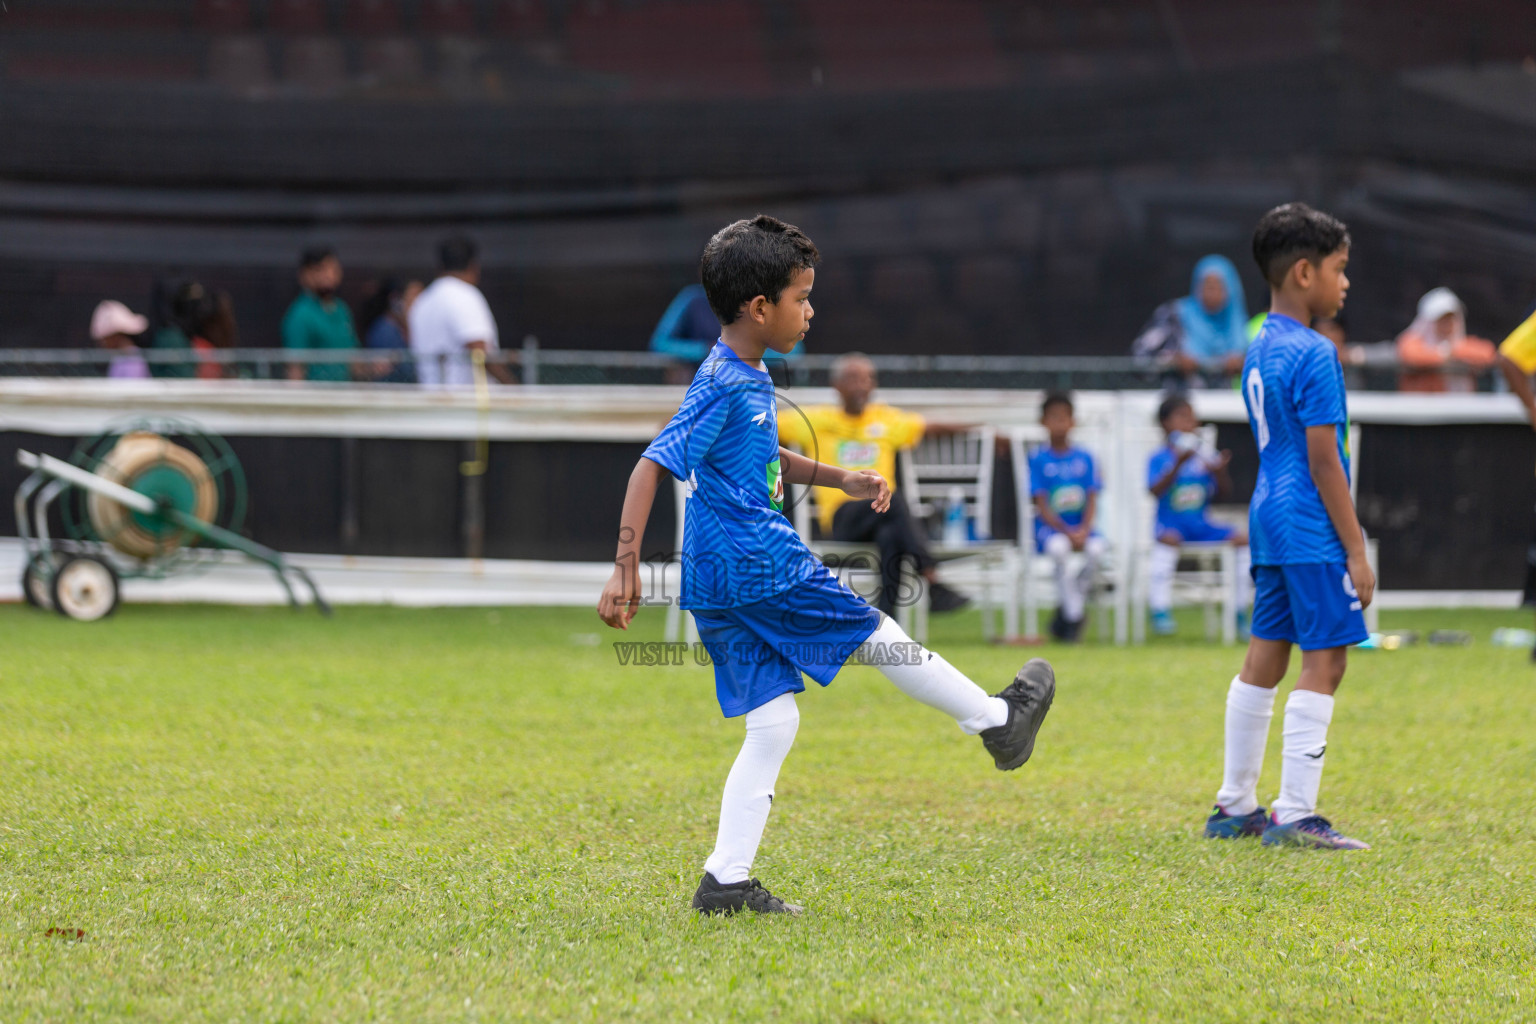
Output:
[1252, 562, 1369, 651]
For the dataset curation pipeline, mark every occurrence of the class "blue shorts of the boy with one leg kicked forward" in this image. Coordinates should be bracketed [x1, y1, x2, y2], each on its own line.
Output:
[693, 565, 880, 718]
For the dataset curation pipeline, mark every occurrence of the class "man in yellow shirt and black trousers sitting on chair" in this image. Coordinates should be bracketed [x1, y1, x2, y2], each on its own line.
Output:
[779, 353, 968, 616]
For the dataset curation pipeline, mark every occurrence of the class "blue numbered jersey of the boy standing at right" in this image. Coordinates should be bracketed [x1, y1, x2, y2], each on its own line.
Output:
[1243, 313, 1350, 565]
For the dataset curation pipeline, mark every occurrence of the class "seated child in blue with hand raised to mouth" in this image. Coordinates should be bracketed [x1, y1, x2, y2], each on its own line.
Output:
[1147, 395, 1249, 639]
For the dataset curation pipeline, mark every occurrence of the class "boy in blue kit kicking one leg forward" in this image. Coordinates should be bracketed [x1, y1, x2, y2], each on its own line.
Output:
[598, 215, 1055, 913]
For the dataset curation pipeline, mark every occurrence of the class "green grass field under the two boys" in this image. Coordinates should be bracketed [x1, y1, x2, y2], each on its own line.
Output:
[0, 606, 1536, 1022]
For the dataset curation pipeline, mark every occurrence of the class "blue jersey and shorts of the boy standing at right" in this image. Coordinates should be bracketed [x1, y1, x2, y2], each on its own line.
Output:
[1243, 313, 1367, 651]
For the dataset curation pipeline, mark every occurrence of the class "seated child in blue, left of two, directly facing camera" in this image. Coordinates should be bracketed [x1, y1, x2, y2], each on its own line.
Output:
[1029, 391, 1109, 642]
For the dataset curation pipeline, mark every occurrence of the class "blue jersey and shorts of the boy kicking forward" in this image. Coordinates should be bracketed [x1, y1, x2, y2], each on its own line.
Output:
[645, 342, 880, 718]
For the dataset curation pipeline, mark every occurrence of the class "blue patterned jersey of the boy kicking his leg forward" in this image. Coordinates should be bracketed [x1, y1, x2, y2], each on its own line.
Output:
[645, 342, 820, 608]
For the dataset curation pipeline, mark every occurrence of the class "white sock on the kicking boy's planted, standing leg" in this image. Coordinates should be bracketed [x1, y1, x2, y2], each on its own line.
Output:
[703, 694, 800, 884]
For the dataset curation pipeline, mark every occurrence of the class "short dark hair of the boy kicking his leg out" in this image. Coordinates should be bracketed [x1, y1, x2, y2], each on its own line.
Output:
[699, 213, 822, 325]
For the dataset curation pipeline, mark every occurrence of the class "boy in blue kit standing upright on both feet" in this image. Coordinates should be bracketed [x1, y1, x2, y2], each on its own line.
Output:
[1206, 203, 1376, 851]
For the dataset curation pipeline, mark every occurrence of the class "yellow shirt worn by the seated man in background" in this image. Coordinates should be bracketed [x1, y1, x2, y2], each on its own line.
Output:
[779, 402, 923, 536]
